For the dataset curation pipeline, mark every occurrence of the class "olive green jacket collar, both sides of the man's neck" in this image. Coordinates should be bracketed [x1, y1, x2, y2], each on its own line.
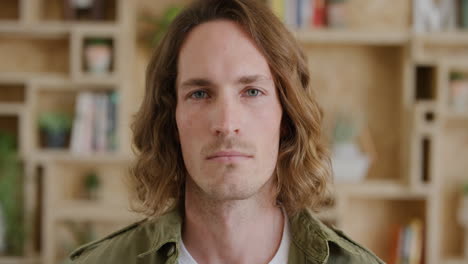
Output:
[138, 206, 359, 264]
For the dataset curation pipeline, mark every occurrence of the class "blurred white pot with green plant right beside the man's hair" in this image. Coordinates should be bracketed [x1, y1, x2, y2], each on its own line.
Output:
[332, 112, 375, 182]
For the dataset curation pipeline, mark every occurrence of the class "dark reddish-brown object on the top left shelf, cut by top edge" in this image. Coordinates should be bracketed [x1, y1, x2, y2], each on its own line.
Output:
[64, 0, 105, 20]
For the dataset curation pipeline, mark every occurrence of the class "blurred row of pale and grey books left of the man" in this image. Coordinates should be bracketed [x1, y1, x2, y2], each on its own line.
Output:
[70, 92, 118, 154]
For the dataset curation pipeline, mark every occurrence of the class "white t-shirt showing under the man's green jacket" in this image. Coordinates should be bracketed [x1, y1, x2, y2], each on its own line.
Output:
[179, 210, 291, 264]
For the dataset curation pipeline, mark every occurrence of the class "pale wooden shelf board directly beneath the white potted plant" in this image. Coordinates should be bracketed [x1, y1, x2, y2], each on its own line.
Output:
[336, 180, 429, 200]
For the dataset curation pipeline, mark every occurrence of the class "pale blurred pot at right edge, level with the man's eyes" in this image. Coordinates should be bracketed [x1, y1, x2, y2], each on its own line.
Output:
[450, 72, 468, 113]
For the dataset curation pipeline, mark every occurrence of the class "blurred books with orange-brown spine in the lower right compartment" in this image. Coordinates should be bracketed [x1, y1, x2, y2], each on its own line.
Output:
[388, 219, 424, 264]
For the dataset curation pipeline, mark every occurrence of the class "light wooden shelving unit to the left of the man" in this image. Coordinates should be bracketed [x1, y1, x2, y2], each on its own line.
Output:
[0, 0, 135, 264]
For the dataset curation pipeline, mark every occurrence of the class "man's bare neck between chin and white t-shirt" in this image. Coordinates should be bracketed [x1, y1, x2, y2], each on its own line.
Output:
[182, 178, 284, 264]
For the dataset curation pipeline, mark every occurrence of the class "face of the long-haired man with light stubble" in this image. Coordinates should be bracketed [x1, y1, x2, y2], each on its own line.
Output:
[176, 20, 282, 200]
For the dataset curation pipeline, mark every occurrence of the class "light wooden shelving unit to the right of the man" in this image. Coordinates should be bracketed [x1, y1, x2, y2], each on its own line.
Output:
[260, 0, 468, 264]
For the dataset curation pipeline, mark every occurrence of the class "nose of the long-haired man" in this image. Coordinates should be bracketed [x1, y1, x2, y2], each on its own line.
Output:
[211, 96, 241, 136]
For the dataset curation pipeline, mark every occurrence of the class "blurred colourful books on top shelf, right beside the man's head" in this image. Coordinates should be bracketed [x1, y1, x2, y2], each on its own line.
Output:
[270, 0, 326, 28]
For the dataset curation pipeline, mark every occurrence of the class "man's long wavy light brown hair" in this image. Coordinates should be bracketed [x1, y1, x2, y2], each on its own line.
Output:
[131, 0, 332, 216]
